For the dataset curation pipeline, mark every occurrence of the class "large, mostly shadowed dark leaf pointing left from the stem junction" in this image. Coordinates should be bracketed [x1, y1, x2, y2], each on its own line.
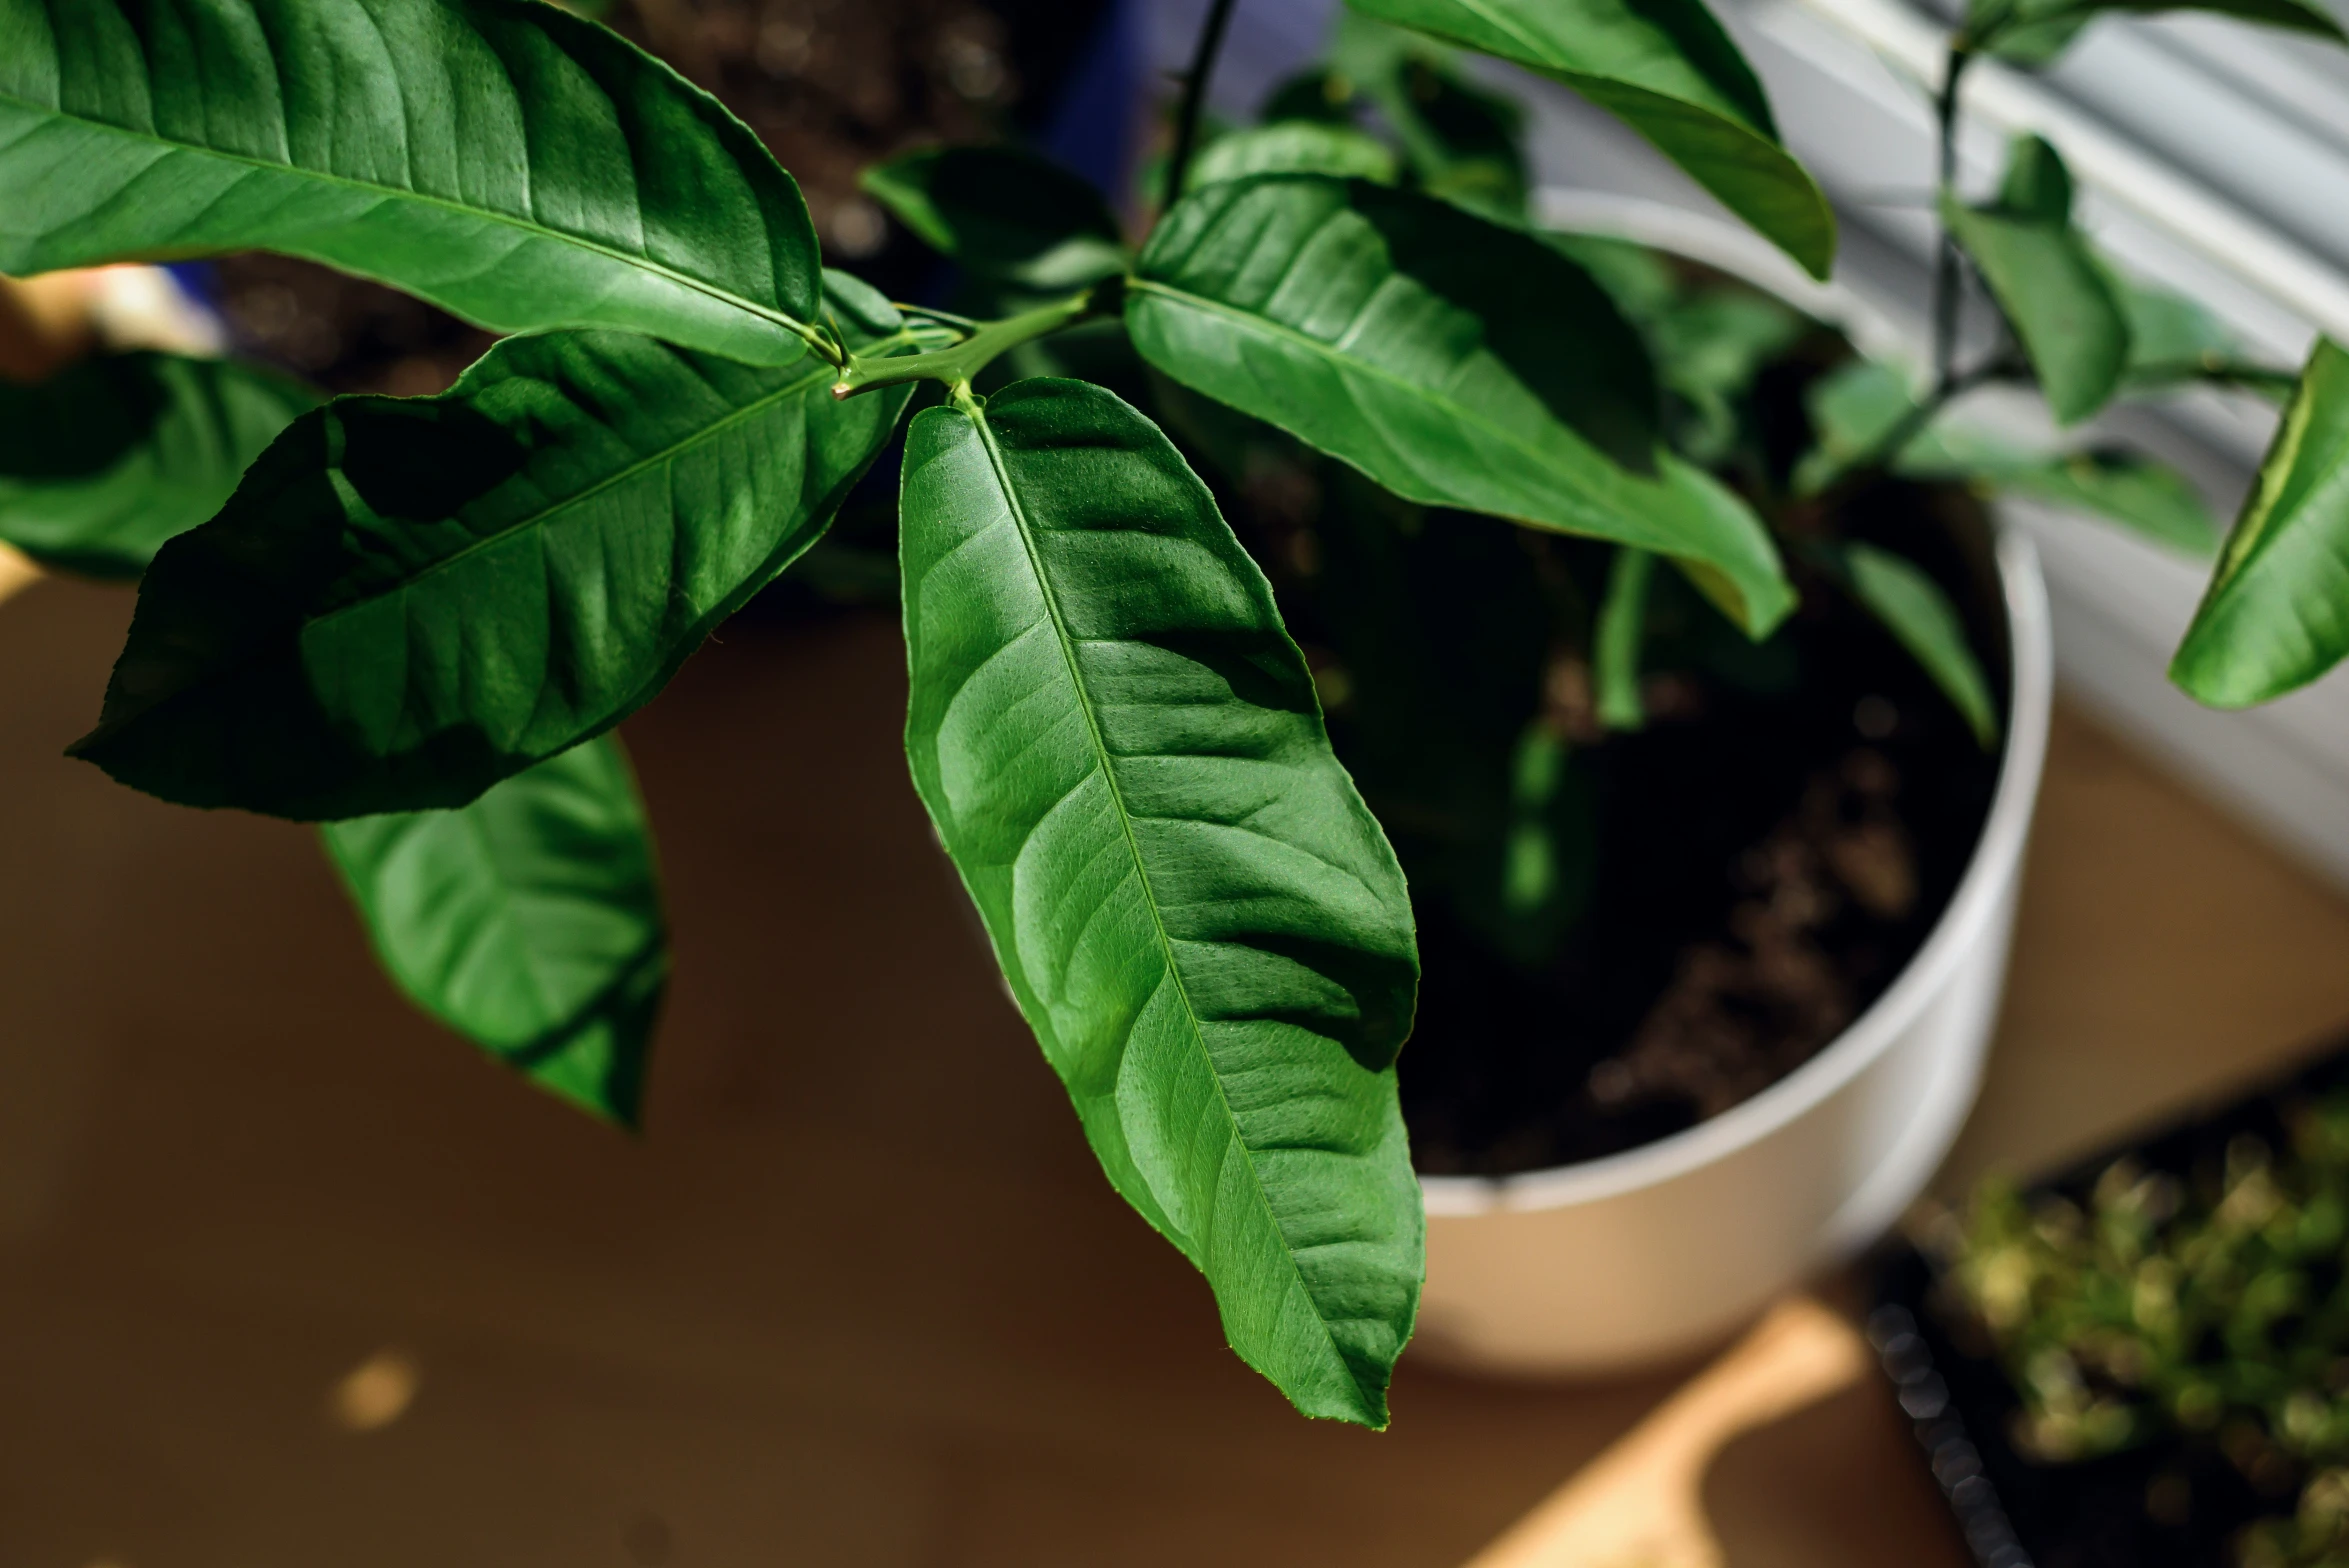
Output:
[75, 277, 909, 819]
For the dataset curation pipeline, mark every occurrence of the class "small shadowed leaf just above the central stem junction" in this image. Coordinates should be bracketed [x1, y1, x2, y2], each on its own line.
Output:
[862, 146, 1125, 289]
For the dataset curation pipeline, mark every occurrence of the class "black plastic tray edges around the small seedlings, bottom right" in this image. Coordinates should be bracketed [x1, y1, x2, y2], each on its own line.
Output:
[1867, 1042, 2349, 1568]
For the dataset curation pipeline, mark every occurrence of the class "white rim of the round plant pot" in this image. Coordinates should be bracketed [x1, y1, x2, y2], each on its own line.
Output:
[1419, 190, 2055, 1216]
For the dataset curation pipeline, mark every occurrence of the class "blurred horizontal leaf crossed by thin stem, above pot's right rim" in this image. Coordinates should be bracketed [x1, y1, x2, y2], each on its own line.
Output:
[1797, 359, 2217, 556]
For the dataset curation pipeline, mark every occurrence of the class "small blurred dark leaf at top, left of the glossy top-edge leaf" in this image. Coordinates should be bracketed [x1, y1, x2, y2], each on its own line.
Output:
[1332, 12, 1527, 225]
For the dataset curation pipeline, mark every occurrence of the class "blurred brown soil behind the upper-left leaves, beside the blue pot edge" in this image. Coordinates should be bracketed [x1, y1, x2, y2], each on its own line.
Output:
[204, 0, 1104, 397]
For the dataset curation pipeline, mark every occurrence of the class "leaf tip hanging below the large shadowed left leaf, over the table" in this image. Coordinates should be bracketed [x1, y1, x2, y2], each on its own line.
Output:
[322, 735, 669, 1127]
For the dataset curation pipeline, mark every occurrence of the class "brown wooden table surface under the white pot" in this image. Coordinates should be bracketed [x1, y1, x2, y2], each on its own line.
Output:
[0, 584, 2349, 1568]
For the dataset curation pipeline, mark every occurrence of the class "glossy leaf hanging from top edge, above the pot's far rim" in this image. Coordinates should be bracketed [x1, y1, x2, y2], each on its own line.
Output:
[1348, 0, 1835, 277]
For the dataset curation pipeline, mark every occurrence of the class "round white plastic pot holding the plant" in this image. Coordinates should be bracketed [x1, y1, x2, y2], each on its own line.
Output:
[1414, 200, 2053, 1373]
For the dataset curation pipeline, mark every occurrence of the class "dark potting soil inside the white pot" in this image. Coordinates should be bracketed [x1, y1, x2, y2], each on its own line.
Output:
[1398, 551, 1997, 1174]
